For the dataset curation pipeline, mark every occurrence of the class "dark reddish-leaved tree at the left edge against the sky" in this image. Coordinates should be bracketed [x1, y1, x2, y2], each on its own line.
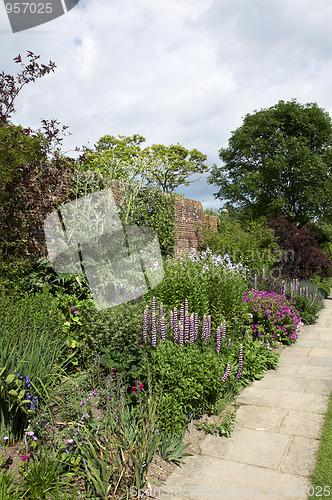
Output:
[0, 52, 73, 257]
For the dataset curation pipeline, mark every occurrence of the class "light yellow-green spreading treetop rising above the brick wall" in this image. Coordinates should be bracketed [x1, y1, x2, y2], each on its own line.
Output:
[81, 134, 208, 193]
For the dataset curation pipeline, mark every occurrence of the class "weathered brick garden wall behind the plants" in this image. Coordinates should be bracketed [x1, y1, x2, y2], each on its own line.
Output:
[25, 170, 218, 257]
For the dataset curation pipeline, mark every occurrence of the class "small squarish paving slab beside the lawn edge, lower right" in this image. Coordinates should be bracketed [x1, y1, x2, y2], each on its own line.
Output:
[279, 411, 324, 439]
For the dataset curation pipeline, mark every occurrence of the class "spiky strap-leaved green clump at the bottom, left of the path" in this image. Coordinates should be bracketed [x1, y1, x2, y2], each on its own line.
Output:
[68, 377, 160, 498]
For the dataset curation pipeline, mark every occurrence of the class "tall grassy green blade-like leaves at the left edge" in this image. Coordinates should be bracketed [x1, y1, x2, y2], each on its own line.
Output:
[0, 292, 66, 436]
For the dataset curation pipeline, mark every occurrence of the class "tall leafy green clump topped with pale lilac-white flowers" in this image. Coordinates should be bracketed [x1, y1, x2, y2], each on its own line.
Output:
[146, 249, 248, 327]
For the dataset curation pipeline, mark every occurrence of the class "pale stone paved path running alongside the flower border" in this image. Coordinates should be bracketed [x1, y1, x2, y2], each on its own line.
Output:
[155, 296, 332, 500]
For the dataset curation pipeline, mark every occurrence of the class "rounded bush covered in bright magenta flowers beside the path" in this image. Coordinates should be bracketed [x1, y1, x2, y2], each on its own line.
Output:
[243, 290, 301, 345]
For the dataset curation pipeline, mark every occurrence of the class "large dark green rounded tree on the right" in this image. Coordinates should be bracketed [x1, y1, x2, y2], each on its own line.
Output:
[208, 99, 332, 225]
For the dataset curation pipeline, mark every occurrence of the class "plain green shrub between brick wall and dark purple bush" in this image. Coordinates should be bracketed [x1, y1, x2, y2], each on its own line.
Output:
[198, 211, 280, 273]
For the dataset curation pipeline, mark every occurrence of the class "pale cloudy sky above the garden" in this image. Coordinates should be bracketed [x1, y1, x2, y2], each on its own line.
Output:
[0, 0, 332, 208]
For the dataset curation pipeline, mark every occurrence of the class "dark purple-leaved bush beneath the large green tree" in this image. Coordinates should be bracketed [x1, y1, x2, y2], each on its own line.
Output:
[268, 215, 332, 279]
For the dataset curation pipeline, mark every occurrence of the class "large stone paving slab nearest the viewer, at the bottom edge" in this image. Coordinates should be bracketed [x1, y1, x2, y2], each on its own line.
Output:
[161, 456, 310, 500]
